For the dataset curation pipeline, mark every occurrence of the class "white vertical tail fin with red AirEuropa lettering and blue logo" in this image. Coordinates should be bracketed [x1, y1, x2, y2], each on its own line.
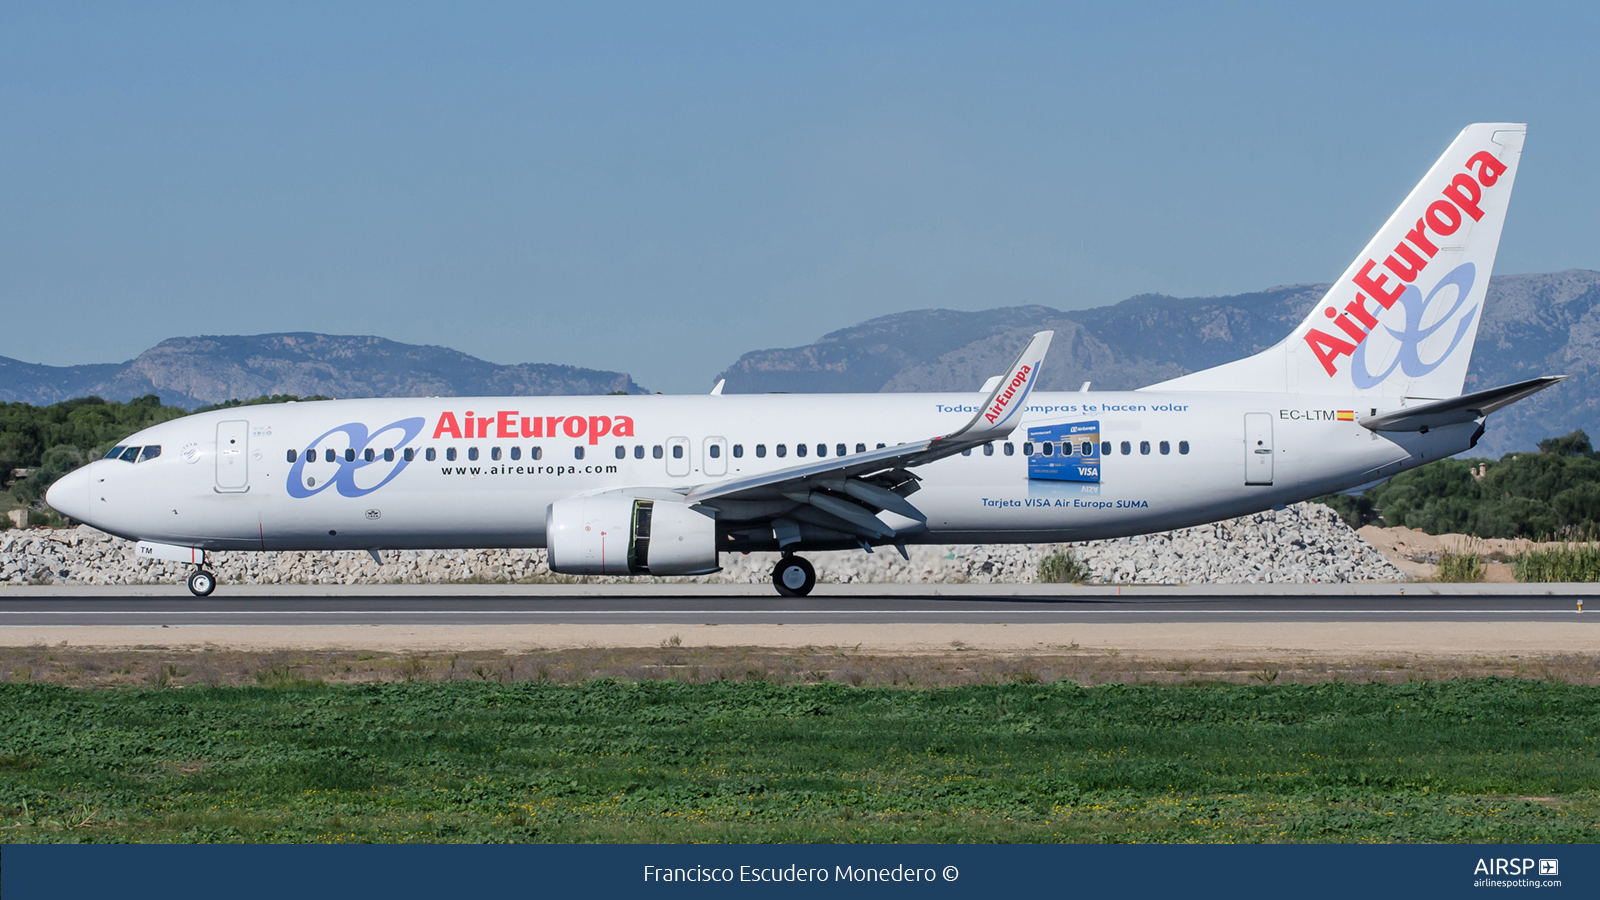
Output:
[1147, 123, 1528, 399]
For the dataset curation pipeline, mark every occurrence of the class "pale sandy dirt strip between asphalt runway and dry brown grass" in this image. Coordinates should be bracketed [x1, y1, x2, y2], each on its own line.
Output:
[0, 615, 1600, 660]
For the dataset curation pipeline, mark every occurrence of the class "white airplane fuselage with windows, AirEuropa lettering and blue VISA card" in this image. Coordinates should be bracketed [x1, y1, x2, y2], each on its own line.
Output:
[50, 391, 1477, 551]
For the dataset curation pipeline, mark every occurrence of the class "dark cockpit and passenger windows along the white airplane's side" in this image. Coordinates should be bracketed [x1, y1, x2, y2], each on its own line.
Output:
[284, 440, 1189, 463]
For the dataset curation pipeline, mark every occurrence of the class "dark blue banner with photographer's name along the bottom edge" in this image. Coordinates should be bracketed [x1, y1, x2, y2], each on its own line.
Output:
[0, 844, 1600, 900]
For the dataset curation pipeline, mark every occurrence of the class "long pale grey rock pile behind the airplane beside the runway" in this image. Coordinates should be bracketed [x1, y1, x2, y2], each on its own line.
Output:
[0, 503, 1405, 585]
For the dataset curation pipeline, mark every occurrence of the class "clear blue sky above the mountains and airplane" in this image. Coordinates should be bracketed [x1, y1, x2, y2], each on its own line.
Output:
[0, 2, 1600, 391]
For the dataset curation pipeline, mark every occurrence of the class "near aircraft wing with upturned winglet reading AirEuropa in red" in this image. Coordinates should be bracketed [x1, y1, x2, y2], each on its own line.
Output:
[685, 331, 1054, 546]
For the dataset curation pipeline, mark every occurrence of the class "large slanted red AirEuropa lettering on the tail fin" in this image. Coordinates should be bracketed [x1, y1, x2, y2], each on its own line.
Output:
[1306, 151, 1506, 376]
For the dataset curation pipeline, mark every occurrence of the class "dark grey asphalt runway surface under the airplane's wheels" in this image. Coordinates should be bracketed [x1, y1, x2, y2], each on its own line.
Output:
[0, 588, 1600, 629]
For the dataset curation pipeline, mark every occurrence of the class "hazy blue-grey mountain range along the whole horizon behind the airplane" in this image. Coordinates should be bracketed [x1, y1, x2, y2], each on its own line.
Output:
[0, 269, 1600, 456]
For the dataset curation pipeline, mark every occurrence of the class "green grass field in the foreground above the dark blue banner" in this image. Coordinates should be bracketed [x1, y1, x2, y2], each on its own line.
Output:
[0, 674, 1600, 842]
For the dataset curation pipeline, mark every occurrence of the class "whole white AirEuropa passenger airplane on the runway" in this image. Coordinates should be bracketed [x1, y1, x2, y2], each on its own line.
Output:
[46, 123, 1565, 596]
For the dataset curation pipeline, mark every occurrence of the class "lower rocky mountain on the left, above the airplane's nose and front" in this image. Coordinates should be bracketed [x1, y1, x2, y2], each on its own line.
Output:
[0, 331, 646, 408]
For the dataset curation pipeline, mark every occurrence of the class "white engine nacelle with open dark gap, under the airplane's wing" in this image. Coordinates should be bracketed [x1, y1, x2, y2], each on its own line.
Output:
[544, 496, 722, 575]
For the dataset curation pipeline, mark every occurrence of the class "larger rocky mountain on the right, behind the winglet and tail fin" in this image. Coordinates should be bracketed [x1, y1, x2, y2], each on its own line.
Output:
[723, 269, 1600, 456]
